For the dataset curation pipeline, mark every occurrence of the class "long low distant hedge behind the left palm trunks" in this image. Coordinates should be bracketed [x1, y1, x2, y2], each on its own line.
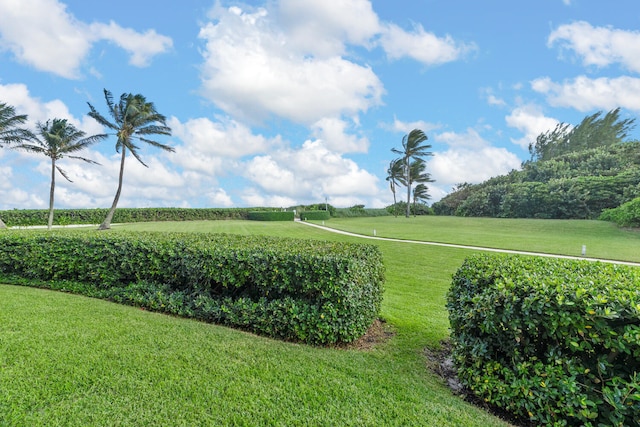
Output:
[0, 208, 284, 227]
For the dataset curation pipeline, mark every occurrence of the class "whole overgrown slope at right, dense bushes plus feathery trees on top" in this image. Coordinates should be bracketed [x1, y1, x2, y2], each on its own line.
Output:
[432, 109, 640, 219]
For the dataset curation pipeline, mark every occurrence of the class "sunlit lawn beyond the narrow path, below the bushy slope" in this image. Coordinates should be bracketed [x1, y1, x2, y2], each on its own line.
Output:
[313, 216, 640, 262]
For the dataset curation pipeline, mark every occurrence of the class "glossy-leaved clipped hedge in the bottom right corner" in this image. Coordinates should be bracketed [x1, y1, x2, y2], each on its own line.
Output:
[447, 255, 640, 426]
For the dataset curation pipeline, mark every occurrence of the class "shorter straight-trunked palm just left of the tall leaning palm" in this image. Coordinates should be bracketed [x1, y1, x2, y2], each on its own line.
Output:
[11, 119, 107, 230]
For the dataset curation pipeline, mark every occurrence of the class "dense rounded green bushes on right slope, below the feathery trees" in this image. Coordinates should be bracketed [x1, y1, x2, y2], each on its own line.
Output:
[432, 141, 640, 219]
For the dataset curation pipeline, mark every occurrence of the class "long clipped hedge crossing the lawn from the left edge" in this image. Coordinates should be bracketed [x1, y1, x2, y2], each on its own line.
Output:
[0, 231, 384, 344]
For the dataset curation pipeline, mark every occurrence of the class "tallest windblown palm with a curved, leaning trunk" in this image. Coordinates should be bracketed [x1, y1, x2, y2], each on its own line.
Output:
[89, 89, 175, 230]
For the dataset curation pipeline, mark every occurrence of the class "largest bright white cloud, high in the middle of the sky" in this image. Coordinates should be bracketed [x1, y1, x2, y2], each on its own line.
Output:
[200, 7, 383, 125]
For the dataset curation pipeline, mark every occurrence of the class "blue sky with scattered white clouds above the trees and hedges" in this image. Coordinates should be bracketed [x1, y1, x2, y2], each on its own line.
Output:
[0, 0, 640, 209]
